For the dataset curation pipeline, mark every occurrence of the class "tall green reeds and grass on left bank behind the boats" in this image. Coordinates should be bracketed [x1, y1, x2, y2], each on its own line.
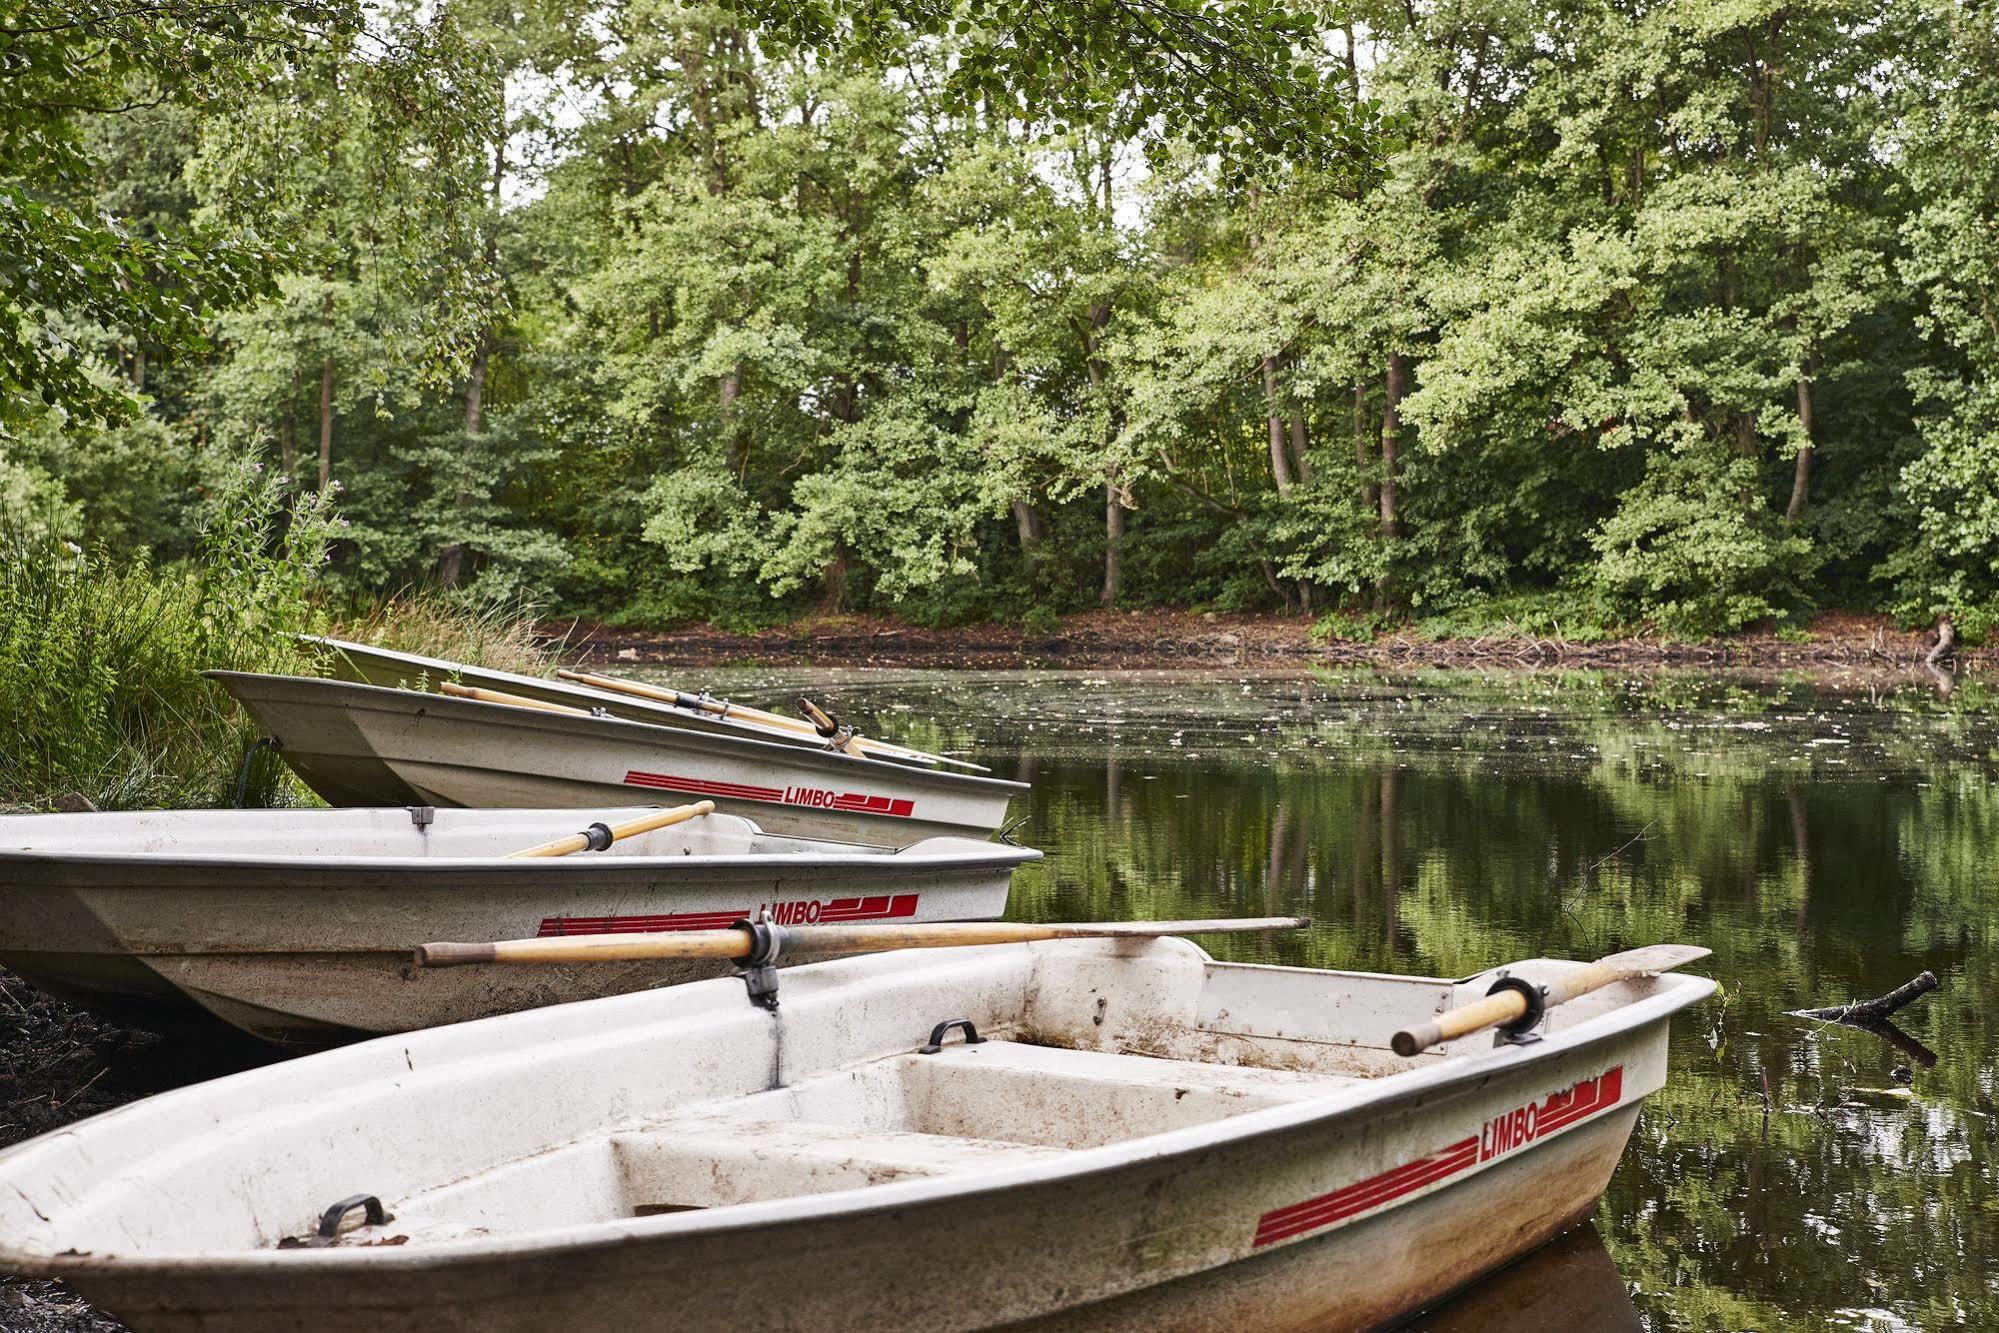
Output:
[0, 460, 548, 809]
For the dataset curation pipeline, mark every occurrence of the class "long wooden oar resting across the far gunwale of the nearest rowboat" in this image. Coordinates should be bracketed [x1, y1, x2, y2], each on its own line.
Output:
[416, 917, 1311, 967]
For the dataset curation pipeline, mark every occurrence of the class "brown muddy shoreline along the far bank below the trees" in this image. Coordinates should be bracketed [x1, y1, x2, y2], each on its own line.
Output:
[542, 612, 1975, 675]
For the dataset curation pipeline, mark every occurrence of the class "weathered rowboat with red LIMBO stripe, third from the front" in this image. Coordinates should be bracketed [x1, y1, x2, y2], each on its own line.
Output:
[208, 671, 1027, 847]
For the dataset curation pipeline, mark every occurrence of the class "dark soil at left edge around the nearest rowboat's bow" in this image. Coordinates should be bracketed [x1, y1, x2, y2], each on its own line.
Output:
[0, 971, 274, 1333]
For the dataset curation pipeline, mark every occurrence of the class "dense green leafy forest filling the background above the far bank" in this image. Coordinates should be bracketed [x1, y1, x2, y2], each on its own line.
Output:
[11, 0, 1999, 638]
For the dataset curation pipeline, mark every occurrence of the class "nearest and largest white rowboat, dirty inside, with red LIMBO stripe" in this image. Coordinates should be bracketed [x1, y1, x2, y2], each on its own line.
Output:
[0, 939, 1713, 1333]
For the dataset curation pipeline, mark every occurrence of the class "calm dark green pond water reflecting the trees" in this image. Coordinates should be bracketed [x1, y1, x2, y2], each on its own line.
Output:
[643, 669, 1999, 1329]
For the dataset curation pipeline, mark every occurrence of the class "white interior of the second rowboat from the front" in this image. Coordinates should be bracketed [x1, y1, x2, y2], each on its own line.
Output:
[0, 805, 923, 859]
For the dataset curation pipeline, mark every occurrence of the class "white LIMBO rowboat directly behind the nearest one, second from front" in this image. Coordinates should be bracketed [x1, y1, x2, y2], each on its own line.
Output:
[0, 807, 1039, 1045]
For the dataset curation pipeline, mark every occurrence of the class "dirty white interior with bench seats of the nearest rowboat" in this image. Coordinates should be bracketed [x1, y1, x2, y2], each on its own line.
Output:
[0, 939, 1707, 1253]
